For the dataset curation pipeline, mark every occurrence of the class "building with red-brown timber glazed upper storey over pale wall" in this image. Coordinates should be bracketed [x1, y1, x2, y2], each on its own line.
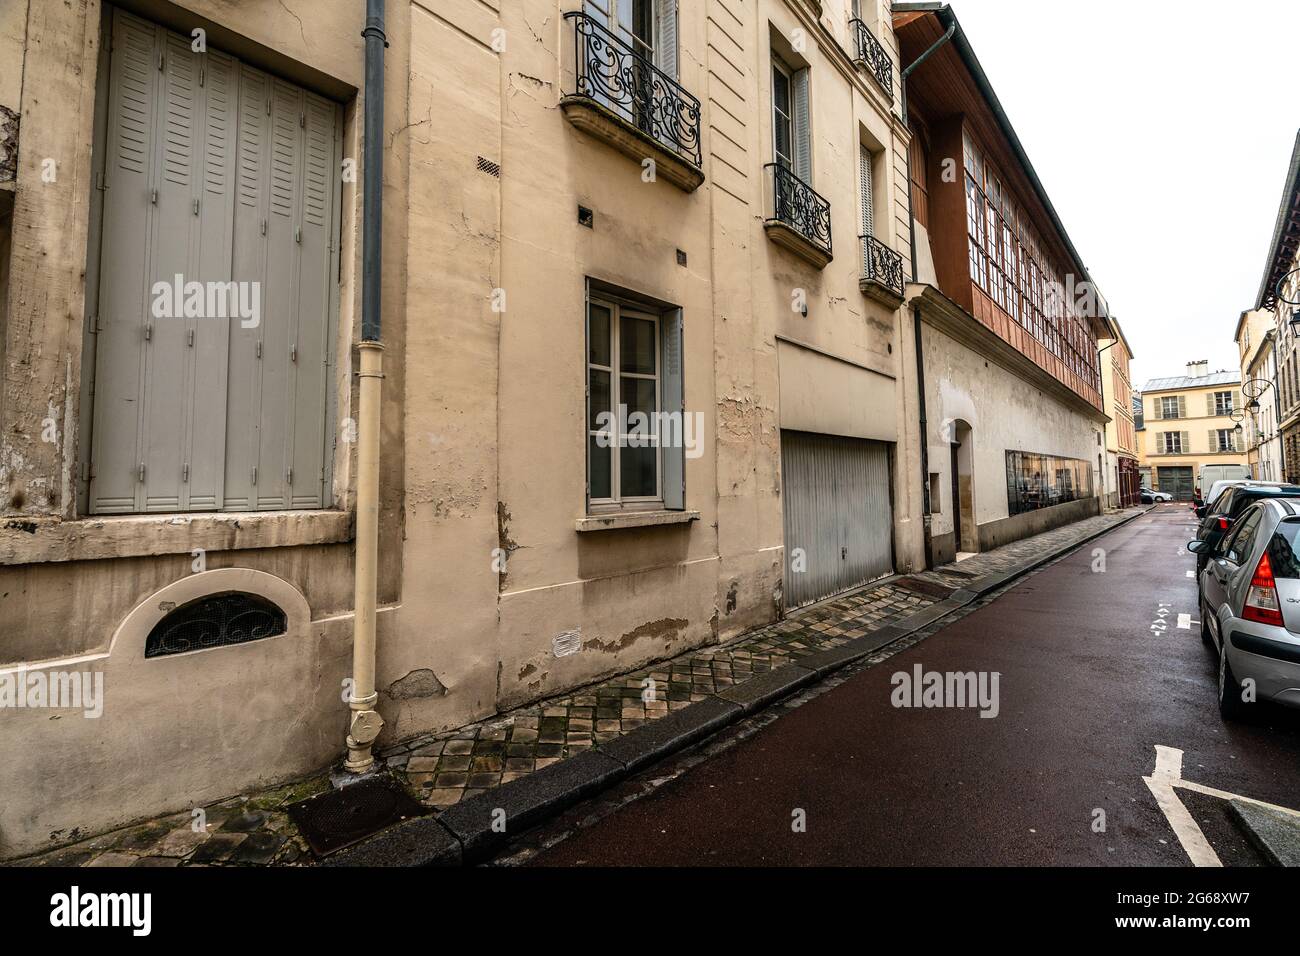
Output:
[893, 3, 1109, 563]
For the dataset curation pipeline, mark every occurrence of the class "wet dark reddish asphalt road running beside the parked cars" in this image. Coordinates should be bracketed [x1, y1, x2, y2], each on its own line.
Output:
[520, 505, 1300, 866]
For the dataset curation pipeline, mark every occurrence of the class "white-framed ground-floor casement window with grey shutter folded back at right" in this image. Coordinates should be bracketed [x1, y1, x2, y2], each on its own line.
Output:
[586, 291, 699, 512]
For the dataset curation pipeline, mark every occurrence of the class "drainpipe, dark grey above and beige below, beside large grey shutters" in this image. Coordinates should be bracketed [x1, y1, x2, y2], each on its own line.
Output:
[343, 0, 387, 774]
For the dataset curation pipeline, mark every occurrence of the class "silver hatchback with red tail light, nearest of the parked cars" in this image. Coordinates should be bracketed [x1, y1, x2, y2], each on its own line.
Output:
[1187, 498, 1300, 718]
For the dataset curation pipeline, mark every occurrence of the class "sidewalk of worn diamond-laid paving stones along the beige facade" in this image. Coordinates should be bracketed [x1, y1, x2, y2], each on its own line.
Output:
[18, 510, 1135, 866]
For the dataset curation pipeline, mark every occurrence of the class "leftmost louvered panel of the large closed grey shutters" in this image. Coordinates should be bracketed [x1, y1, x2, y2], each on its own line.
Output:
[90, 10, 160, 514]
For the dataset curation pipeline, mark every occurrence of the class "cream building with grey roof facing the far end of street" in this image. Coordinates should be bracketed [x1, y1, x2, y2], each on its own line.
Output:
[1141, 362, 1247, 501]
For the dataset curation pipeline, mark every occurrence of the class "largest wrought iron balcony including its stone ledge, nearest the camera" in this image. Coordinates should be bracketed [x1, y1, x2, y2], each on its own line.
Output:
[560, 12, 705, 191]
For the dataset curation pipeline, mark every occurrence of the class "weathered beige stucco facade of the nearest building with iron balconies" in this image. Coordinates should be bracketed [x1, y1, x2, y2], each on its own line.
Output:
[0, 0, 935, 856]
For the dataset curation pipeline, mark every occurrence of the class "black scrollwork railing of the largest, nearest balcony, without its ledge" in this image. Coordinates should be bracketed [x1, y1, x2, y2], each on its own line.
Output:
[564, 12, 703, 169]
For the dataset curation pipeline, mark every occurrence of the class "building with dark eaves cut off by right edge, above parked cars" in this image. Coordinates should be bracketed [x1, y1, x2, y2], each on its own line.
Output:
[1255, 133, 1300, 481]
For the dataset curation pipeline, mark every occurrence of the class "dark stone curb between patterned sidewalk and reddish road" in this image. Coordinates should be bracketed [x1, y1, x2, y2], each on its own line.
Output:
[335, 509, 1151, 866]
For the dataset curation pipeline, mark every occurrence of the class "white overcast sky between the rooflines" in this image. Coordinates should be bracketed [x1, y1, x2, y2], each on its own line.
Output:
[952, 0, 1300, 388]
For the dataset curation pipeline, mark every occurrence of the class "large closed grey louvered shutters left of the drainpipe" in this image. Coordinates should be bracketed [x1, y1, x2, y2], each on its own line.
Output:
[83, 10, 342, 514]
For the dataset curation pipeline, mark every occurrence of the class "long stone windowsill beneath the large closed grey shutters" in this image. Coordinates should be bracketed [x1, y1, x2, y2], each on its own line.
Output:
[0, 510, 354, 566]
